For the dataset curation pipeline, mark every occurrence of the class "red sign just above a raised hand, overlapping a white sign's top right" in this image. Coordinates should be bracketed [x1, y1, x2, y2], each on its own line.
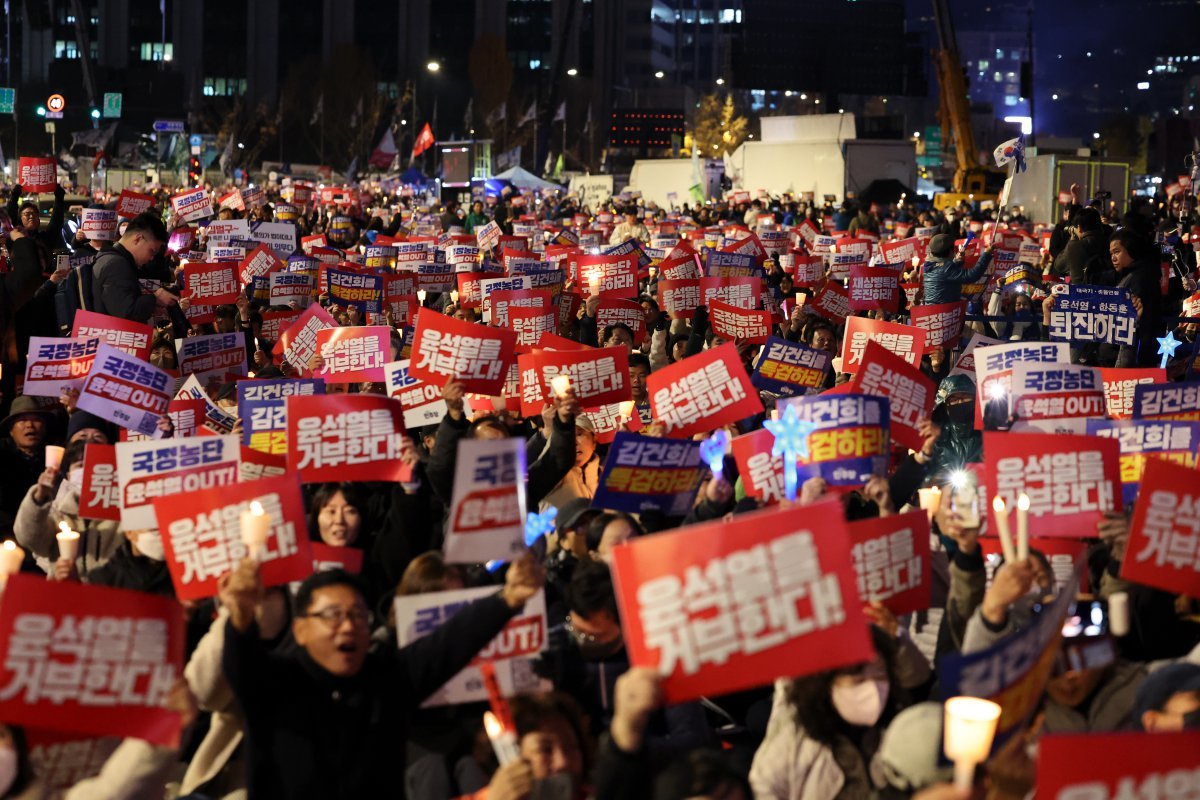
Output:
[408, 308, 517, 395]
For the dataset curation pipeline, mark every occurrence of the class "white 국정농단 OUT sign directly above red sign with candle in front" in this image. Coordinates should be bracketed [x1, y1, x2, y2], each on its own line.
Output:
[116, 435, 240, 530]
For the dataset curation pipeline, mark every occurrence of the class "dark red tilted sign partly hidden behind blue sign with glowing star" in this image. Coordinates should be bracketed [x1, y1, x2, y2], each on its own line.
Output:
[850, 342, 937, 450]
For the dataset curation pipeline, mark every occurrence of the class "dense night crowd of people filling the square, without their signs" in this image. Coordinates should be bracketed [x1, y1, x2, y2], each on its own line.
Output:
[0, 163, 1200, 800]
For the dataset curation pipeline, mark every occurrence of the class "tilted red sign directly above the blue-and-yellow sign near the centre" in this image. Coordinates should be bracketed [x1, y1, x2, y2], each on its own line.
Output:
[646, 342, 762, 438]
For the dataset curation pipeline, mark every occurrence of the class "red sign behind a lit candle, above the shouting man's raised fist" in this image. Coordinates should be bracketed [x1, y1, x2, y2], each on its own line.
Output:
[154, 475, 312, 600]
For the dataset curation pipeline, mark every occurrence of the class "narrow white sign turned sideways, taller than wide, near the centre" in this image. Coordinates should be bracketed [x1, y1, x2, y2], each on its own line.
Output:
[445, 438, 526, 564]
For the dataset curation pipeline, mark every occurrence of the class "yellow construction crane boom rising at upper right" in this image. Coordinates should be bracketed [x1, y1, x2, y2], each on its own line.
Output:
[932, 0, 1006, 210]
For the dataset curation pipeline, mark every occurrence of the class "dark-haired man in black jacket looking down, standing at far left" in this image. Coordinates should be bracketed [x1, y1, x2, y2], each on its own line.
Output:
[91, 211, 175, 323]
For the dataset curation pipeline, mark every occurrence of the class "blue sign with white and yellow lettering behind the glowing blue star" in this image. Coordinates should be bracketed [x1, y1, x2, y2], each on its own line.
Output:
[778, 393, 890, 486]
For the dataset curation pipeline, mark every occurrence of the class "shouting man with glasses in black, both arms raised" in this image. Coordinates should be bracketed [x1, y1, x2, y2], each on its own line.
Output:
[221, 557, 545, 800]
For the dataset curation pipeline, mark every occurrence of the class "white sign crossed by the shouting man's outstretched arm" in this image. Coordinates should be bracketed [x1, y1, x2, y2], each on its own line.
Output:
[394, 587, 552, 708]
